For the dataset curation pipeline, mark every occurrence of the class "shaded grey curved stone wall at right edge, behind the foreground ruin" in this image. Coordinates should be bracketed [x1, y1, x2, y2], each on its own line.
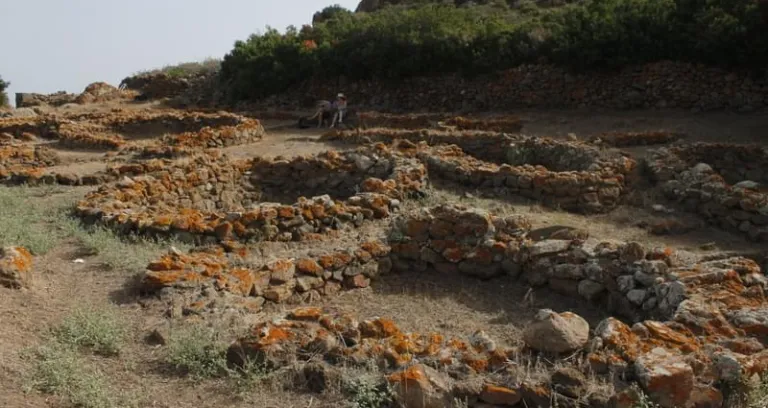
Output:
[648, 143, 768, 241]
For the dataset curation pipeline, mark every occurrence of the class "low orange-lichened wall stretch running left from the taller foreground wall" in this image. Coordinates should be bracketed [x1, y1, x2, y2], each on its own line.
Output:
[142, 242, 391, 313]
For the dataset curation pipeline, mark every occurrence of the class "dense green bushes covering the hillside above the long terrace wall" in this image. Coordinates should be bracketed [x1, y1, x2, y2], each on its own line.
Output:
[221, 0, 768, 100]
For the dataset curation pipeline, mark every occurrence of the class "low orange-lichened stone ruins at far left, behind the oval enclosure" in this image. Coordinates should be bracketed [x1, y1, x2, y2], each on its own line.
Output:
[0, 110, 264, 185]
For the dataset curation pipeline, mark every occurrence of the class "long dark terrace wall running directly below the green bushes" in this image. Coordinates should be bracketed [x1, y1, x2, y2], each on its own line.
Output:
[260, 62, 768, 112]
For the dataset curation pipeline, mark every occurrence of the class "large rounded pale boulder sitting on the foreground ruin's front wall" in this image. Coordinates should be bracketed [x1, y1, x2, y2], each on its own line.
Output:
[523, 309, 589, 353]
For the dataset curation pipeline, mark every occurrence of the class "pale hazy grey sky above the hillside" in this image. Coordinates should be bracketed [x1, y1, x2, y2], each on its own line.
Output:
[0, 0, 359, 105]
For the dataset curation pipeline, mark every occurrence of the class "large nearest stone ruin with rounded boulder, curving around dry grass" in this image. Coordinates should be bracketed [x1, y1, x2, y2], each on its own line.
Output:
[143, 205, 768, 408]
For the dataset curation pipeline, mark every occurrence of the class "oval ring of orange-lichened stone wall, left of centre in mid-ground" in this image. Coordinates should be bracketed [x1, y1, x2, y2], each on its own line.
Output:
[77, 146, 426, 243]
